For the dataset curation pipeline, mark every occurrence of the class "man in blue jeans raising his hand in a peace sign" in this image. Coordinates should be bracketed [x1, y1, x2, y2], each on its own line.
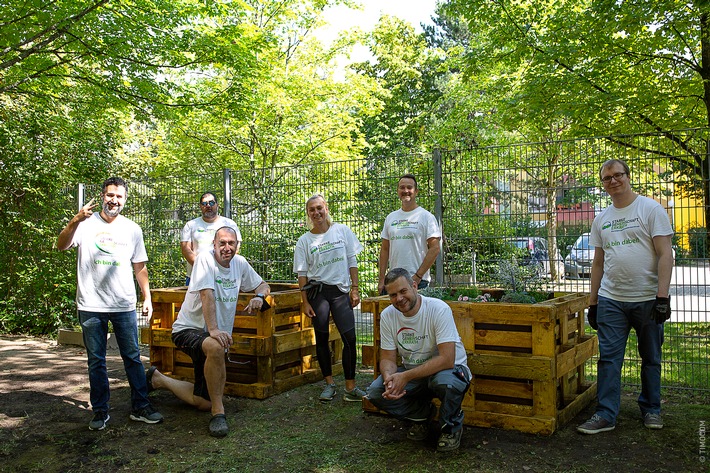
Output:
[57, 177, 163, 430]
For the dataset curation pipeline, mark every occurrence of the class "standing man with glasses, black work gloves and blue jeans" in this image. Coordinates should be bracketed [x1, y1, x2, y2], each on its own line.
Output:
[577, 159, 673, 434]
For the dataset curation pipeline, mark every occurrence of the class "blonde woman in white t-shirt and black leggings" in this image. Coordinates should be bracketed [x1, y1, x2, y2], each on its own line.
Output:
[293, 194, 365, 402]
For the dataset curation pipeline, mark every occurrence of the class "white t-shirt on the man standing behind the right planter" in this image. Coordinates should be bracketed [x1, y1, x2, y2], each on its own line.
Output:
[382, 207, 441, 281]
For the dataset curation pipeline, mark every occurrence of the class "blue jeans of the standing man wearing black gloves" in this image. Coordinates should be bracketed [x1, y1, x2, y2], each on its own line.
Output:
[597, 297, 663, 423]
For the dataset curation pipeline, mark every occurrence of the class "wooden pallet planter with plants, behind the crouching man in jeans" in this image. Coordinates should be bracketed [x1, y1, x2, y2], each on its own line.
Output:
[362, 291, 598, 435]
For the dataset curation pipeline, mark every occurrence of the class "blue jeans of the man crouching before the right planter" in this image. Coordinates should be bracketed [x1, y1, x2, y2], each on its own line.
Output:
[367, 366, 470, 433]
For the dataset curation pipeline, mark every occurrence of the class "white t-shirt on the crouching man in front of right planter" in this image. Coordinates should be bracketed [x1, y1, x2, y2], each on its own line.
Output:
[380, 296, 471, 377]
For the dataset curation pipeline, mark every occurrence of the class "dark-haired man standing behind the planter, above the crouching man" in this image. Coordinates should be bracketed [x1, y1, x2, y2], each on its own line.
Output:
[377, 174, 441, 294]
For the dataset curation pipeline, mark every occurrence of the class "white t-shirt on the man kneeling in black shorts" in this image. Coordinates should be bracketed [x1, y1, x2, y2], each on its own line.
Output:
[173, 251, 263, 333]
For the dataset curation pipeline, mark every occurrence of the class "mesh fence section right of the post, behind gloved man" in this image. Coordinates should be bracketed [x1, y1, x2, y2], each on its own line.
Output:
[442, 130, 710, 391]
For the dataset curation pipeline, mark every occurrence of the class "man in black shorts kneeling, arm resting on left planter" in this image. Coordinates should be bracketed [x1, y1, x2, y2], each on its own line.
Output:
[146, 227, 270, 437]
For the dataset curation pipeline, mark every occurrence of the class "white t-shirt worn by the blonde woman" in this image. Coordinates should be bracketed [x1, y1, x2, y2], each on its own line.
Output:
[293, 223, 363, 292]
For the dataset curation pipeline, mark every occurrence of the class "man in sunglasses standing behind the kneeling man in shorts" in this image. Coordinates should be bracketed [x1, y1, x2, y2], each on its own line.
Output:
[180, 192, 242, 286]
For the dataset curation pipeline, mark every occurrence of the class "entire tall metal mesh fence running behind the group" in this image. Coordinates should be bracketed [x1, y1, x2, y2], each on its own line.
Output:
[73, 130, 710, 391]
